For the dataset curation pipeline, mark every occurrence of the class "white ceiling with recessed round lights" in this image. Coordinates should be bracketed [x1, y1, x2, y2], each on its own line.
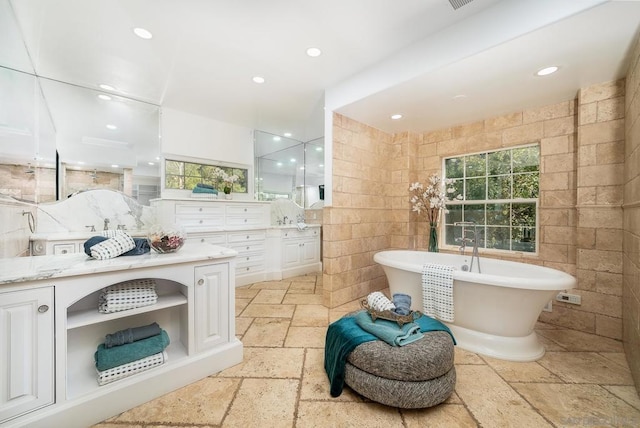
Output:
[5, 0, 640, 141]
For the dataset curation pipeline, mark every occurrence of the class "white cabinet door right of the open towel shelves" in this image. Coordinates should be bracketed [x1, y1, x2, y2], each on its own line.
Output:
[195, 263, 233, 352]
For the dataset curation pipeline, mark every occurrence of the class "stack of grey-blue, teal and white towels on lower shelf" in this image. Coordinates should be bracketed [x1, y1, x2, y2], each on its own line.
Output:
[94, 323, 170, 385]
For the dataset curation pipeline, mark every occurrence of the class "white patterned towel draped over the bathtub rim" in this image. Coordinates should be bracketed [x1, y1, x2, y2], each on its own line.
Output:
[422, 263, 454, 322]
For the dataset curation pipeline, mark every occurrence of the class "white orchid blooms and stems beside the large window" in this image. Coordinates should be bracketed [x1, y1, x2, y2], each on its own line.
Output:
[409, 174, 462, 225]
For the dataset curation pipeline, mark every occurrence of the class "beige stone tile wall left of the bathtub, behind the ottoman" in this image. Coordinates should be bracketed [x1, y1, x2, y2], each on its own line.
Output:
[322, 114, 396, 308]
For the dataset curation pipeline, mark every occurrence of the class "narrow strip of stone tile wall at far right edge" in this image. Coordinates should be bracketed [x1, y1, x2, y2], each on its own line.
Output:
[622, 31, 640, 388]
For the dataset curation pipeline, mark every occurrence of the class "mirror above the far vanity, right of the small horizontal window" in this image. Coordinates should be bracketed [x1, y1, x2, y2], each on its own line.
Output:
[255, 131, 324, 209]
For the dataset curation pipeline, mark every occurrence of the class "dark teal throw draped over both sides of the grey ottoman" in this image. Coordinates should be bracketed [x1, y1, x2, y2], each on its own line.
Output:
[324, 310, 456, 397]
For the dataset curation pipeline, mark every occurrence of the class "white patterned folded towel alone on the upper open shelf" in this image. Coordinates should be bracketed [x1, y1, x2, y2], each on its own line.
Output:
[98, 278, 158, 314]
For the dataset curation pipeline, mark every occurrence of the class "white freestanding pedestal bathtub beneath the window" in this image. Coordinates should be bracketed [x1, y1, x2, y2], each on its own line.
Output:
[373, 250, 576, 361]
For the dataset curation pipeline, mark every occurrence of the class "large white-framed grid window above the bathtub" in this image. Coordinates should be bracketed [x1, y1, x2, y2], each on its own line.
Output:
[444, 144, 540, 253]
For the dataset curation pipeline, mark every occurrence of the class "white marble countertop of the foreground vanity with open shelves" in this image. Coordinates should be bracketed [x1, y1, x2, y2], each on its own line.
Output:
[0, 242, 238, 285]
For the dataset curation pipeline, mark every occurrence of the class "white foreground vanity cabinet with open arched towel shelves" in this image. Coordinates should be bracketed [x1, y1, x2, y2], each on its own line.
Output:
[0, 242, 242, 428]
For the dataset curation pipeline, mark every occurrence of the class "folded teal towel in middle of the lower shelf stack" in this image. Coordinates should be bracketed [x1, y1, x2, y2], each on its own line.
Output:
[94, 330, 170, 371]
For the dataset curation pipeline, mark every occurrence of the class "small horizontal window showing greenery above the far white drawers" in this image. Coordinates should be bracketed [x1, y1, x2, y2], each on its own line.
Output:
[164, 159, 249, 193]
